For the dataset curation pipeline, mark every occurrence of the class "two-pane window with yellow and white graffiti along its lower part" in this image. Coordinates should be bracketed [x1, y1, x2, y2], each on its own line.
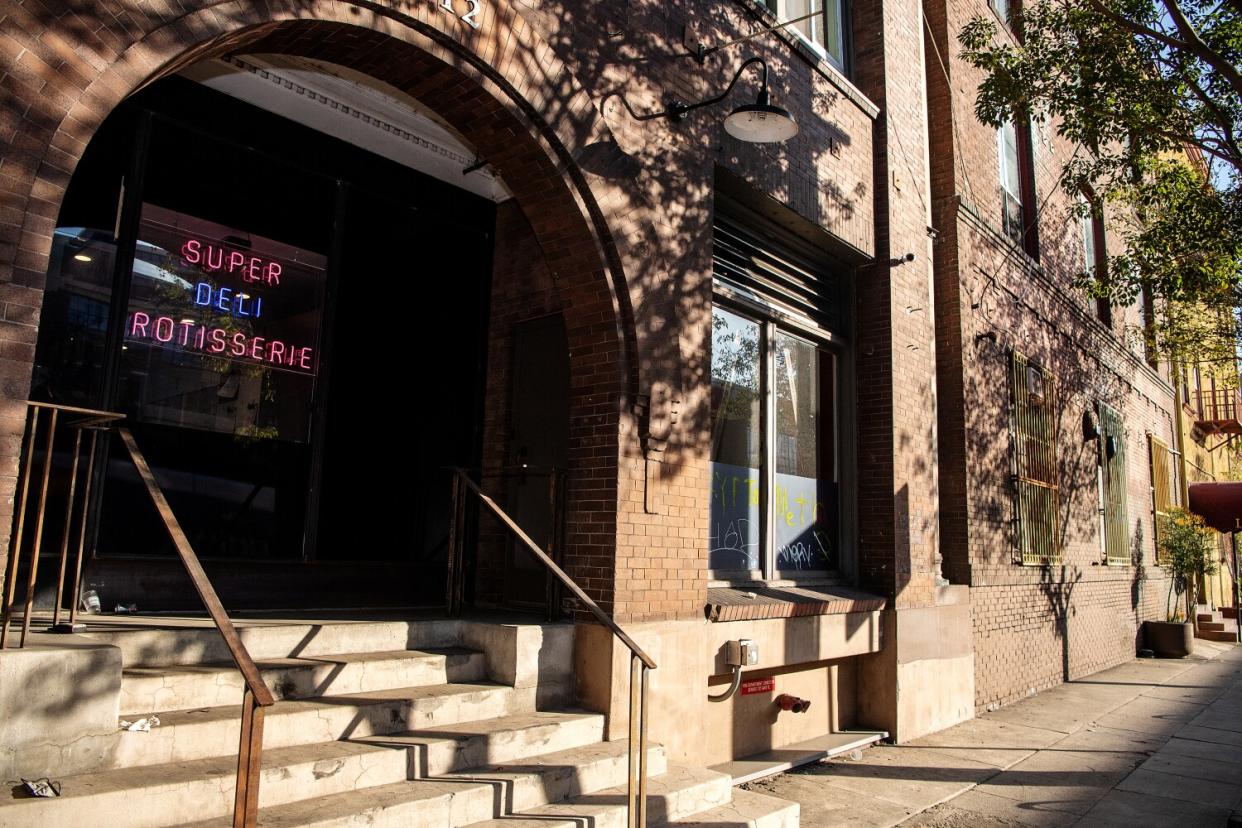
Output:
[709, 307, 840, 578]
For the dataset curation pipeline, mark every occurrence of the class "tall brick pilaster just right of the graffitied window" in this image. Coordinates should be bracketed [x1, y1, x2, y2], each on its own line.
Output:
[853, 1, 940, 608]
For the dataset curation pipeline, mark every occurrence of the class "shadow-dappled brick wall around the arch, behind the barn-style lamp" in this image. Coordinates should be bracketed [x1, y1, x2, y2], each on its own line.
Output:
[0, 0, 874, 628]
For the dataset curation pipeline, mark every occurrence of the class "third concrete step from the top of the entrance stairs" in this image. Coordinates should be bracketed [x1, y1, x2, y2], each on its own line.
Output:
[116, 682, 519, 767]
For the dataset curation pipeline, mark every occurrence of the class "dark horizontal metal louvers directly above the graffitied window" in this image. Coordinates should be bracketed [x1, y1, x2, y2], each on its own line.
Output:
[712, 211, 845, 331]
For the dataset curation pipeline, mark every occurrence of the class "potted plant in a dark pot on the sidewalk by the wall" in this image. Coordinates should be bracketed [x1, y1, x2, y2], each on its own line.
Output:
[1143, 508, 1217, 658]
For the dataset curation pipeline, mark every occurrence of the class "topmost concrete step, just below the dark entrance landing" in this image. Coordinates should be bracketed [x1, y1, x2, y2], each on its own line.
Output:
[88, 619, 463, 667]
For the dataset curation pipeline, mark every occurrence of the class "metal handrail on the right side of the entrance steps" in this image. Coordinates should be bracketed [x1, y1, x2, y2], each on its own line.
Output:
[447, 468, 656, 828]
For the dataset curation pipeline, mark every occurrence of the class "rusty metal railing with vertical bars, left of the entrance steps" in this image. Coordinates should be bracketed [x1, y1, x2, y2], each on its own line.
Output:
[0, 402, 276, 828]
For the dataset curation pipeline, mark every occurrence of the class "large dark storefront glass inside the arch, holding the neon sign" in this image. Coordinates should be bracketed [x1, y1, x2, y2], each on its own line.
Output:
[32, 78, 494, 602]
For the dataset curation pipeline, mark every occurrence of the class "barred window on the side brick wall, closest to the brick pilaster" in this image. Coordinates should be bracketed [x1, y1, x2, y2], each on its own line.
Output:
[1011, 351, 1061, 566]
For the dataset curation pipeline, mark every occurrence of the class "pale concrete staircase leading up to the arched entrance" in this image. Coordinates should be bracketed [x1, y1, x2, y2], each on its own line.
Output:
[0, 621, 799, 828]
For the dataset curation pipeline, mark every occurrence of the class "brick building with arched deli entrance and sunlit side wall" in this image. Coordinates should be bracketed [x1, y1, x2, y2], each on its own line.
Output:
[0, 0, 1207, 821]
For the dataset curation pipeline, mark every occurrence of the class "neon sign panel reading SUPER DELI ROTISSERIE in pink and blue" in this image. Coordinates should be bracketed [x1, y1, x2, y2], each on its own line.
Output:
[120, 204, 328, 442]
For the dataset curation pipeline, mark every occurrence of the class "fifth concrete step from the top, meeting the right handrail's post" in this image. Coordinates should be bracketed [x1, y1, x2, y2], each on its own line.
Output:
[172, 741, 664, 828]
